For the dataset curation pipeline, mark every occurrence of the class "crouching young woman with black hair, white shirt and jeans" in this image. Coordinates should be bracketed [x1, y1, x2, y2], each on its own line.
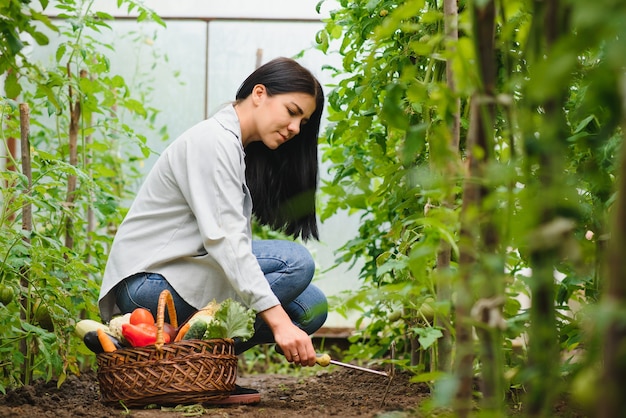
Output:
[99, 58, 327, 382]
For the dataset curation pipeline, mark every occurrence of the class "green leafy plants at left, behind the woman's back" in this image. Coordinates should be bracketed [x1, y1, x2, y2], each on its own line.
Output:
[0, 0, 166, 391]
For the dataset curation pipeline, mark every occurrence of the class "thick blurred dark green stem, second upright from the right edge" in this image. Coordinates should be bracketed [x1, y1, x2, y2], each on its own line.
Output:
[526, 0, 571, 417]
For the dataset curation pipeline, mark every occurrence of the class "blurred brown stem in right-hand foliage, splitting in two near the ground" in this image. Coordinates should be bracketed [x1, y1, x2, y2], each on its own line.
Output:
[456, 0, 503, 417]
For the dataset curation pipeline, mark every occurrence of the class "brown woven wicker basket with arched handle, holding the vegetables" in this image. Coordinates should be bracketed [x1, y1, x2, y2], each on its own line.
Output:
[97, 290, 237, 406]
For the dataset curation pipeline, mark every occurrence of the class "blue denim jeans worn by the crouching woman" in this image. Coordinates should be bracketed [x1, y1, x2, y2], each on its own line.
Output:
[116, 240, 328, 354]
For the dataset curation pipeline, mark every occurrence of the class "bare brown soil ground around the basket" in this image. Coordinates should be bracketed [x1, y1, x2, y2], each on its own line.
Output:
[0, 369, 429, 418]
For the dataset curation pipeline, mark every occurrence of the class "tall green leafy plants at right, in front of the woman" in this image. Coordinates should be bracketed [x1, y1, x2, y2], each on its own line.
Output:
[318, 0, 626, 414]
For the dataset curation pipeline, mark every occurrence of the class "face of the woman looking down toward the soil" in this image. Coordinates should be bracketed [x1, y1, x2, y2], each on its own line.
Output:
[253, 86, 315, 149]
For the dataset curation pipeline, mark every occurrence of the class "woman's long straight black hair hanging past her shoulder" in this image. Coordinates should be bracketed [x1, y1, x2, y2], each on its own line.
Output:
[236, 58, 324, 240]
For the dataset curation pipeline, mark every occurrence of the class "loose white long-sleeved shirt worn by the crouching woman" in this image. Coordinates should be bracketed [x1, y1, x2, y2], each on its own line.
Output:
[99, 105, 280, 321]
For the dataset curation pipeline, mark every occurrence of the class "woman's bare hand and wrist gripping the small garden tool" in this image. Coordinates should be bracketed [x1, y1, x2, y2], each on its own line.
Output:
[260, 305, 316, 366]
